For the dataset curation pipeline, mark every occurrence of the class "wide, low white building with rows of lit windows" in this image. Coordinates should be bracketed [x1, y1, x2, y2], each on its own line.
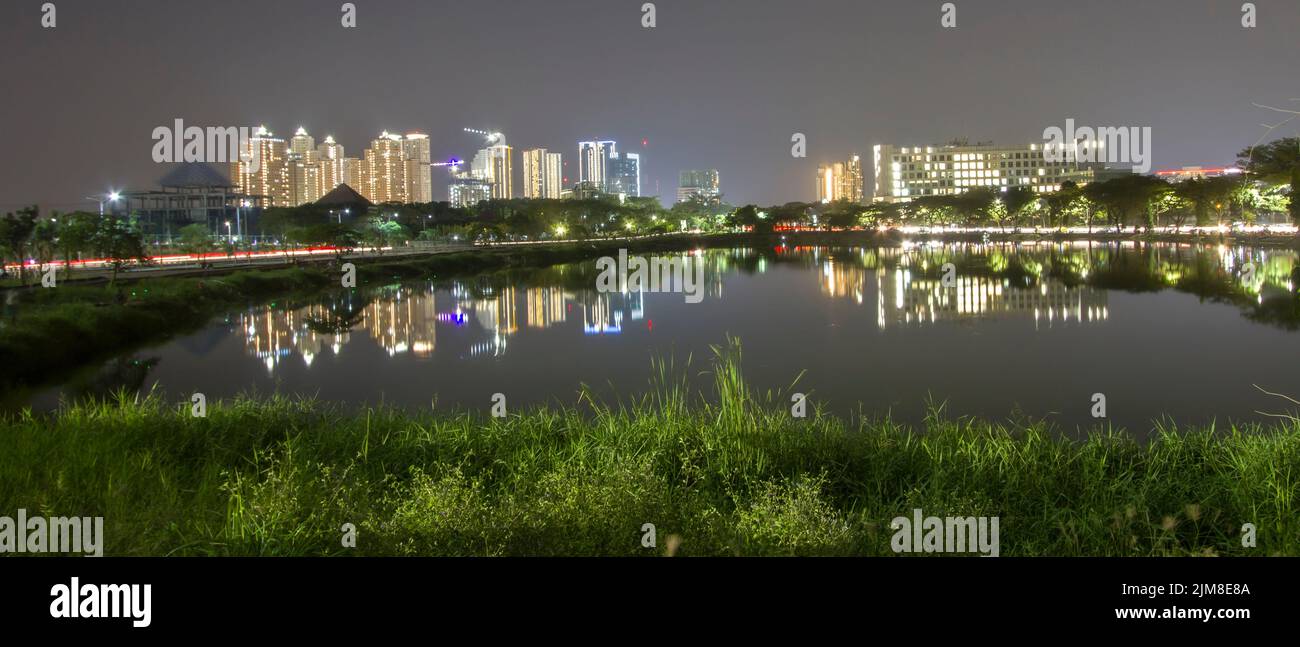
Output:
[872, 142, 1097, 203]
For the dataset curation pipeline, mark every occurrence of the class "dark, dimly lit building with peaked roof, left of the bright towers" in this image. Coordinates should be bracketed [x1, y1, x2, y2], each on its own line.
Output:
[111, 162, 263, 240]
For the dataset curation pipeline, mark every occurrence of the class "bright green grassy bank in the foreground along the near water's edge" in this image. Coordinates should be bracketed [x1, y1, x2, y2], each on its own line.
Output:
[0, 348, 1300, 556]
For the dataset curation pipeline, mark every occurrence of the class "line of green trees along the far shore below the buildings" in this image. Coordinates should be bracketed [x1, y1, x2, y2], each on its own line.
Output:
[0, 138, 1300, 283]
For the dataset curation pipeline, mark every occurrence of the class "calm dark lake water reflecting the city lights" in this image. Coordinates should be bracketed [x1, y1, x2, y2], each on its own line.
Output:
[17, 243, 1300, 431]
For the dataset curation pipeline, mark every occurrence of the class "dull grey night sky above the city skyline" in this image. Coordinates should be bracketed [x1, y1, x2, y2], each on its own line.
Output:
[0, 0, 1300, 210]
